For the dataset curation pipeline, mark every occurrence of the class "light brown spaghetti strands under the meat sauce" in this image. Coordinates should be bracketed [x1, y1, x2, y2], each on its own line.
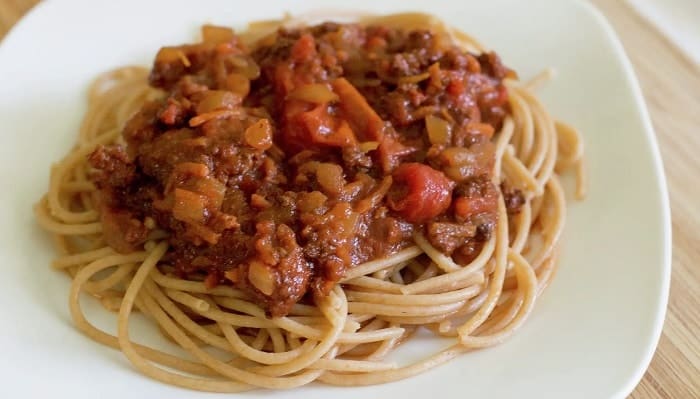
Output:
[35, 14, 585, 392]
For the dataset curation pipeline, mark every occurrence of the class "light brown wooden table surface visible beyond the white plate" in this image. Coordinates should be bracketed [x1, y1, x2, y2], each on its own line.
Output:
[0, 0, 700, 399]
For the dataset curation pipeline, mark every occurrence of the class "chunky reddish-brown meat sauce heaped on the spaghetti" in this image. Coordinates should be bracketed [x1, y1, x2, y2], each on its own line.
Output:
[90, 23, 523, 316]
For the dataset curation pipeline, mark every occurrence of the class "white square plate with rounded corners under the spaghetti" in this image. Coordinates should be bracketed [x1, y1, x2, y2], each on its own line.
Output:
[0, 0, 671, 399]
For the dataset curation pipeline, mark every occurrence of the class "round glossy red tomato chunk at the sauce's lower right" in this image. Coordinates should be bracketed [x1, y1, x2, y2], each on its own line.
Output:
[388, 162, 454, 223]
